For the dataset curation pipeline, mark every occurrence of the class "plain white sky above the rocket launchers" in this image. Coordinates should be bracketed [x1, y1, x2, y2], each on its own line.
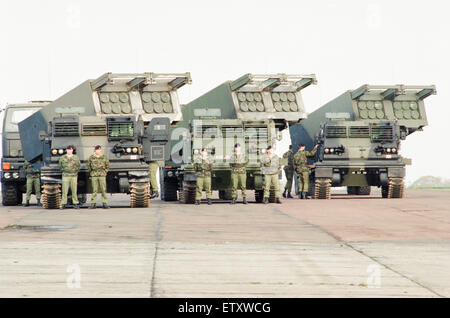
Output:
[0, 0, 450, 182]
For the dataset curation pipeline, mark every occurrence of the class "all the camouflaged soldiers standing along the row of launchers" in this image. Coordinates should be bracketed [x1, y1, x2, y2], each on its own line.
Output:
[24, 143, 318, 209]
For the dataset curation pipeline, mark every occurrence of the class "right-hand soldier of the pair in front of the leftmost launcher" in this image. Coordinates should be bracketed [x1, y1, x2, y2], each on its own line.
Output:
[88, 145, 109, 209]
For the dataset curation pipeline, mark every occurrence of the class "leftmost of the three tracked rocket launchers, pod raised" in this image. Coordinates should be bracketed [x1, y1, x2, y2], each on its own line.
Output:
[19, 73, 191, 208]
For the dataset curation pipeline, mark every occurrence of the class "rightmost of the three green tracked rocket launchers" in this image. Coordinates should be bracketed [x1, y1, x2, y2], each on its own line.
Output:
[290, 85, 436, 199]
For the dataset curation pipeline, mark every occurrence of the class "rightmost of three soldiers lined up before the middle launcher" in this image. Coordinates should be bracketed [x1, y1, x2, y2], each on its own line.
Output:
[260, 146, 281, 204]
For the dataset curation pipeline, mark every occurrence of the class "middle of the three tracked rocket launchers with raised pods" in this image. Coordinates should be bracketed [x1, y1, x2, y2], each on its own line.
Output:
[161, 74, 316, 203]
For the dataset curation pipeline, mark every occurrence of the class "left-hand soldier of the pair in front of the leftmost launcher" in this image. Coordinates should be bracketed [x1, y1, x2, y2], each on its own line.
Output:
[59, 145, 81, 209]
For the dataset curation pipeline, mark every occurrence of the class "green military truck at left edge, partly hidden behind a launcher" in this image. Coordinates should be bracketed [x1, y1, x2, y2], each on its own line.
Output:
[1, 101, 50, 205]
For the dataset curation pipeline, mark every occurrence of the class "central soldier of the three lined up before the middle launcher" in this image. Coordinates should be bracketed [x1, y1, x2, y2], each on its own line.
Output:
[231, 144, 248, 204]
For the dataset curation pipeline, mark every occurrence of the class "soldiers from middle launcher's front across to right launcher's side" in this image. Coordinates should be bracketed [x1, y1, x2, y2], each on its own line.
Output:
[194, 143, 318, 205]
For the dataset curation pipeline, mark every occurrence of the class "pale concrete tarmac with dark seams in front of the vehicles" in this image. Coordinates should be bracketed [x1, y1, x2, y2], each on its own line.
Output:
[0, 189, 450, 297]
